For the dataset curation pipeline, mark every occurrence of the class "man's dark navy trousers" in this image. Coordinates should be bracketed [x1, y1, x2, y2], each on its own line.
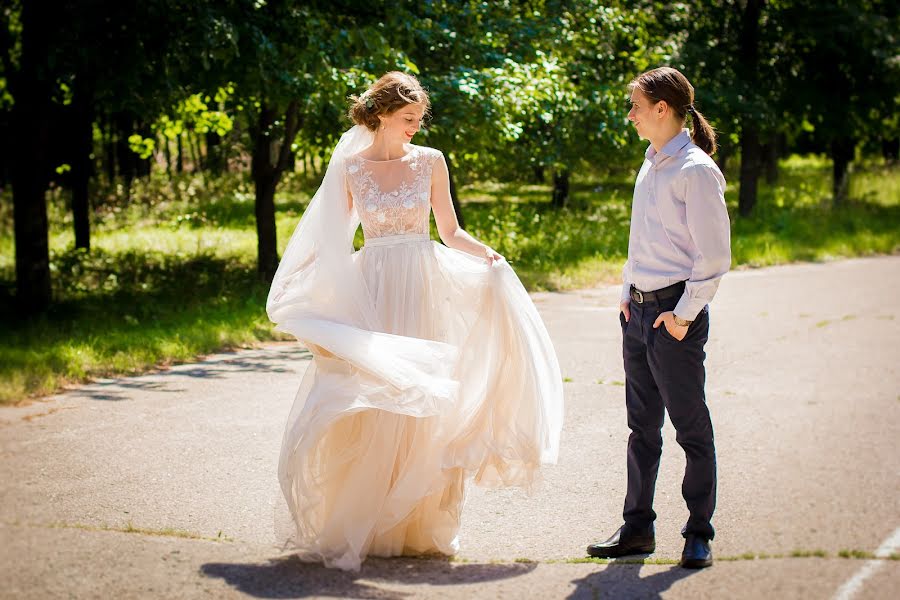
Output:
[619, 296, 716, 539]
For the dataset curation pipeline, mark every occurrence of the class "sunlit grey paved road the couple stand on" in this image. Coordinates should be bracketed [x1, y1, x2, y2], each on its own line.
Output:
[0, 257, 900, 598]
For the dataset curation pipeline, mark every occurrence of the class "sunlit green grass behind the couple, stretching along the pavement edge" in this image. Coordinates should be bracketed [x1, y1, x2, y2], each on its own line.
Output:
[0, 157, 900, 404]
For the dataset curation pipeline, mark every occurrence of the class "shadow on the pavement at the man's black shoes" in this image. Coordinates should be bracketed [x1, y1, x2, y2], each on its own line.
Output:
[569, 562, 698, 600]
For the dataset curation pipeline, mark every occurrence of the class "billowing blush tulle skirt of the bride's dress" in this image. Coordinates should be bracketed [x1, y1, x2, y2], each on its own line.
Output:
[275, 234, 563, 570]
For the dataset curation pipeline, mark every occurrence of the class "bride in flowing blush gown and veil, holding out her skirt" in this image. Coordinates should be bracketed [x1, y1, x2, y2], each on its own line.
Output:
[266, 72, 563, 570]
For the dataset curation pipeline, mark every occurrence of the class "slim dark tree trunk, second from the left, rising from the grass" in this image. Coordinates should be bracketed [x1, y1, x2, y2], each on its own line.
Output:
[72, 83, 94, 250]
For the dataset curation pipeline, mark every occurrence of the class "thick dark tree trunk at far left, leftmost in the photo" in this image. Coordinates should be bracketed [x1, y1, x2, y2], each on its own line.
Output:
[8, 2, 55, 316]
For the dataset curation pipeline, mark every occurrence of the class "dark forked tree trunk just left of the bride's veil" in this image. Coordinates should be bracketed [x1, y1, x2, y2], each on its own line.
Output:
[250, 101, 300, 282]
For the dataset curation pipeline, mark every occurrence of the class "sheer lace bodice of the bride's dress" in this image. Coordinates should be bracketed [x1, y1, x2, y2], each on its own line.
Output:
[347, 146, 441, 239]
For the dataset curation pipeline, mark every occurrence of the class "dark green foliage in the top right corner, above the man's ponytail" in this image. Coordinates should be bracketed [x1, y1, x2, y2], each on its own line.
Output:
[668, 0, 900, 149]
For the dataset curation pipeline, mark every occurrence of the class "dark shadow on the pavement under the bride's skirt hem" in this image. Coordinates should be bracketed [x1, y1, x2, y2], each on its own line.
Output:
[201, 556, 537, 599]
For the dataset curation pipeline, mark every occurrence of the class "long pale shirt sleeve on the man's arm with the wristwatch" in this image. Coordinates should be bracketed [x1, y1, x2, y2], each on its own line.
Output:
[674, 164, 731, 321]
